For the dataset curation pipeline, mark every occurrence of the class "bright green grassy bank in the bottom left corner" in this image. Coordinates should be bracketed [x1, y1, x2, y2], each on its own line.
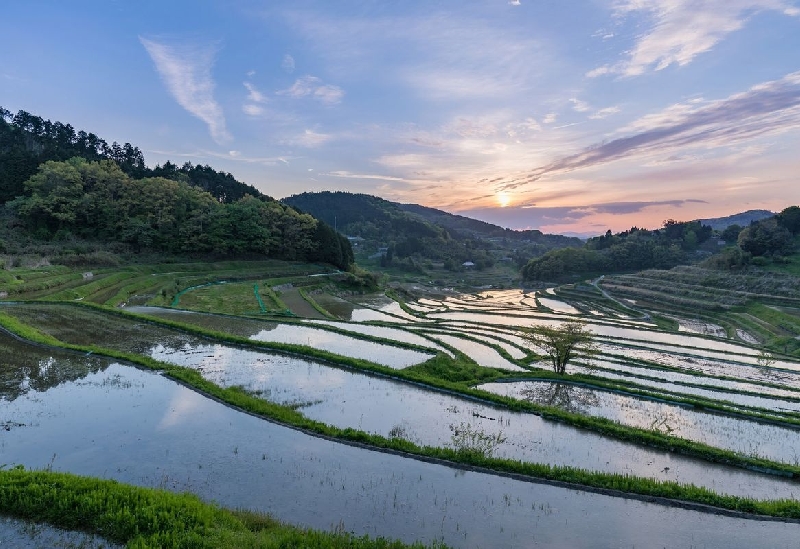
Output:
[0, 468, 443, 549]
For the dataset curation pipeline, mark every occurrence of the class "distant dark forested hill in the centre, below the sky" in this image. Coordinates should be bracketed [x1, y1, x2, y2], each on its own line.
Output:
[283, 191, 583, 270]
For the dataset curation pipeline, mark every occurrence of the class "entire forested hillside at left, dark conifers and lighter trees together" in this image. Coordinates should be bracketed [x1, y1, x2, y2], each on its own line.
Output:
[0, 108, 353, 269]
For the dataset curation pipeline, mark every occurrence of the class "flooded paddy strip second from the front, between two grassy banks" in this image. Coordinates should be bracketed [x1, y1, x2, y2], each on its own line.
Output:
[145, 345, 798, 498]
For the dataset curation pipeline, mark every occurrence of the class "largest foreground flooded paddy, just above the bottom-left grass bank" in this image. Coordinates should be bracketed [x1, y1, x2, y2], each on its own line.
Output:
[0, 348, 800, 548]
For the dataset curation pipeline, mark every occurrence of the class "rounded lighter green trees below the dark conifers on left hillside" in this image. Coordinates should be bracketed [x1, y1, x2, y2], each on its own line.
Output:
[9, 157, 353, 268]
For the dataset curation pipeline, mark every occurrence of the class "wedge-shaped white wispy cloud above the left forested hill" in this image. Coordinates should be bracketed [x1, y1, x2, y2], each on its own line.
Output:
[139, 36, 231, 143]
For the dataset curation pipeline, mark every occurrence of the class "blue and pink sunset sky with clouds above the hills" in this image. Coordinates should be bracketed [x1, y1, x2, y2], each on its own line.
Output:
[0, 0, 800, 235]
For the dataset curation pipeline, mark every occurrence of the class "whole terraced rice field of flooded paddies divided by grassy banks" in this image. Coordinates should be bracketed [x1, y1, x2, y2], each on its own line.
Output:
[0, 265, 800, 547]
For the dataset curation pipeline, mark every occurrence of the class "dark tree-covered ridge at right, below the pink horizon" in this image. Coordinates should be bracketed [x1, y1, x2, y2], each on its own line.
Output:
[522, 206, 800, 282]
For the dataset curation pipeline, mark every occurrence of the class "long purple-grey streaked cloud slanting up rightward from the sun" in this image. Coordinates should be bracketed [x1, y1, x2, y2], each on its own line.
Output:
[500, 72, 800, 189]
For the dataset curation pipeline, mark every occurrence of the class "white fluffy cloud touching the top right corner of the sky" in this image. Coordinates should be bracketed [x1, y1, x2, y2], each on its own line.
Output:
[587, 0, 800, 77]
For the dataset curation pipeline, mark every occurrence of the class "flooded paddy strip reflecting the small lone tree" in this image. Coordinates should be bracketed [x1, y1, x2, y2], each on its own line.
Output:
[479, 381, 800, 464]
